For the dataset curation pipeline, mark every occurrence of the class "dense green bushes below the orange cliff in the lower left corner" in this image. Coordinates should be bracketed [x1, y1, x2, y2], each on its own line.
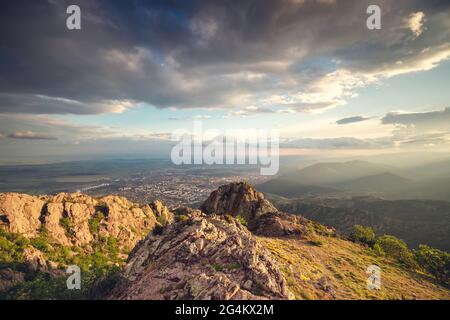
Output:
[0, 226, 124, 300]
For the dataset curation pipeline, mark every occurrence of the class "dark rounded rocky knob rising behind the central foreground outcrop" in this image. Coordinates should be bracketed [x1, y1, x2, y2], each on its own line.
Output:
[200, 182, 308, 237]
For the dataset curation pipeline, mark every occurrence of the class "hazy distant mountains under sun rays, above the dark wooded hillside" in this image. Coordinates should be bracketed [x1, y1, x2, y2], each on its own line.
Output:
[258, 160, 450, 200]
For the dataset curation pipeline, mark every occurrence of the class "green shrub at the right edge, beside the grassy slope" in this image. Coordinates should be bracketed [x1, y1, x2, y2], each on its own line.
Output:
[414, 245, 450, 284]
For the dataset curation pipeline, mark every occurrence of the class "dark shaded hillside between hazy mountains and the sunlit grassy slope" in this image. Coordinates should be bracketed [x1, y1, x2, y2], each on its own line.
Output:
[271, 197, 450, 251]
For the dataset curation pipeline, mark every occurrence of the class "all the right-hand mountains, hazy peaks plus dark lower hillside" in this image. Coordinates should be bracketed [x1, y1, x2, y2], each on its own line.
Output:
[258, 161, 450, 251]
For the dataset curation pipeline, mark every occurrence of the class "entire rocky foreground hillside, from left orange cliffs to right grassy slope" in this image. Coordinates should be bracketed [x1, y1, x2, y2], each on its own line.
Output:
[0, 183, 450, 300]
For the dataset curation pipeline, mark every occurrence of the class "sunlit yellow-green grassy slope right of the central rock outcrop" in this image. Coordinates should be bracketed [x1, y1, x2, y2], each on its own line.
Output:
[258, 236, 450, 300]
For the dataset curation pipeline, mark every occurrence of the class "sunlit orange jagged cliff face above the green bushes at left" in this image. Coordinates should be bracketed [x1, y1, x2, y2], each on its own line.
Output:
[0, 193, 173, 249]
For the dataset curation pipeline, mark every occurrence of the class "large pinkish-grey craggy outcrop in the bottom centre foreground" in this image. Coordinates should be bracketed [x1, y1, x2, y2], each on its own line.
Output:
[109, 213, 292, 299]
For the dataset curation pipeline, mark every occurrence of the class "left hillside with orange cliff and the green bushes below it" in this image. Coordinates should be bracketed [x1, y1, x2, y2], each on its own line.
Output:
[0, 193, 173, 299]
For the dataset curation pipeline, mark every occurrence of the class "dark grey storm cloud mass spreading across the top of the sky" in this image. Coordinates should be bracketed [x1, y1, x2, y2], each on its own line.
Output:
[0, 0, 450, 114]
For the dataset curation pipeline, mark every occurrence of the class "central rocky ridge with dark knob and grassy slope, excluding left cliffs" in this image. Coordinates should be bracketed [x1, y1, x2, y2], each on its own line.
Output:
[0, 183, 449, 299]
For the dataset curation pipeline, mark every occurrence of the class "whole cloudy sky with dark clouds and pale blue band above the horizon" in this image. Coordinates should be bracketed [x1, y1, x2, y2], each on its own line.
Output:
[0, 0, 450, 163]
